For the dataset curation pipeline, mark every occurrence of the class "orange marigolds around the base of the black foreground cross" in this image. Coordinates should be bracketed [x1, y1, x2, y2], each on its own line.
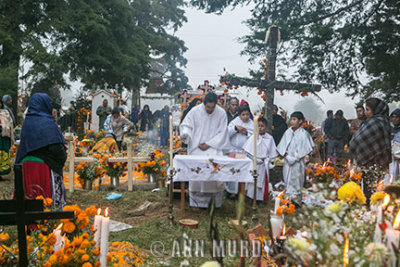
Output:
[0, 204, 148, 267]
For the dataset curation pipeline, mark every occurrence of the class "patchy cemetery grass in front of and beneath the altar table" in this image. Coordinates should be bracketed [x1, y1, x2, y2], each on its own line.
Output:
[0, 177, 273, 266]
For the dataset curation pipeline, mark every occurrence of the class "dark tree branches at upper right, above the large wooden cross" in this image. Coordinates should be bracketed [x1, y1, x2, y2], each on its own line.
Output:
[191, 0, 400, 100]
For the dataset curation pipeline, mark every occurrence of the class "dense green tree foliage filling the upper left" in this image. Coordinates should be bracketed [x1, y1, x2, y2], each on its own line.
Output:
[0, 0, 187, 98]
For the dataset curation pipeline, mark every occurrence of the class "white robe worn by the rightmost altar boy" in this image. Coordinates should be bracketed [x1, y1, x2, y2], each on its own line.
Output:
[277, 128, 314, 198]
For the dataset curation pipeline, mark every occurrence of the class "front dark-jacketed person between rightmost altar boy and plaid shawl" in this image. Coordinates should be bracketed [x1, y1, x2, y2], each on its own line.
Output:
[325, 110, 350, 159]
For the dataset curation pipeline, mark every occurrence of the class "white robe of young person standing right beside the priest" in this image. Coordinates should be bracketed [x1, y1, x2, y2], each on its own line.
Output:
[226, 117, 254, 194]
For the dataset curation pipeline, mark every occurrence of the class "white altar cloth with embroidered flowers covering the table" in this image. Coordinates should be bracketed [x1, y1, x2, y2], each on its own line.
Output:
[173, 155, 253, 183]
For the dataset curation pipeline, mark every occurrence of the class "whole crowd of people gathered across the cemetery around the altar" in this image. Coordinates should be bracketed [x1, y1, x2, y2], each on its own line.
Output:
[0, 89, 400, 213]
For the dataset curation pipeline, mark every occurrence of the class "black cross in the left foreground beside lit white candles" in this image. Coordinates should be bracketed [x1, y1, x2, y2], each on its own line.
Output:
[0, 164, 74, 267]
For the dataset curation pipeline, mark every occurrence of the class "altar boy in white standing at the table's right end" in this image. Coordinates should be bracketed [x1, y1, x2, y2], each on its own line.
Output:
[243, 118, 278, 201]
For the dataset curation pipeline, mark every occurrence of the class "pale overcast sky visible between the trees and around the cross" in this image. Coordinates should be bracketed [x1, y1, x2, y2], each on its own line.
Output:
[177, 7, 364, 121]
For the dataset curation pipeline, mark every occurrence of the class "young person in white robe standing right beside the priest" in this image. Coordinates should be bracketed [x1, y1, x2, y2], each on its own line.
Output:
[226, 105, 254, 194]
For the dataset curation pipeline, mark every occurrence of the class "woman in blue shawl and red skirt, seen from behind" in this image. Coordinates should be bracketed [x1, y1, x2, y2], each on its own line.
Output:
[15, 93, 67, 209]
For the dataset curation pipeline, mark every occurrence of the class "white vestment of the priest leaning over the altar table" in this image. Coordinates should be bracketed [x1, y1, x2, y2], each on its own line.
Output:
[180, 104, 228, 208]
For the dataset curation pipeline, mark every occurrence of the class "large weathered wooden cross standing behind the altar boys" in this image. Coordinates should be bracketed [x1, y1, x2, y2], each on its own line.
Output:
[220, 26, 321, 133]
